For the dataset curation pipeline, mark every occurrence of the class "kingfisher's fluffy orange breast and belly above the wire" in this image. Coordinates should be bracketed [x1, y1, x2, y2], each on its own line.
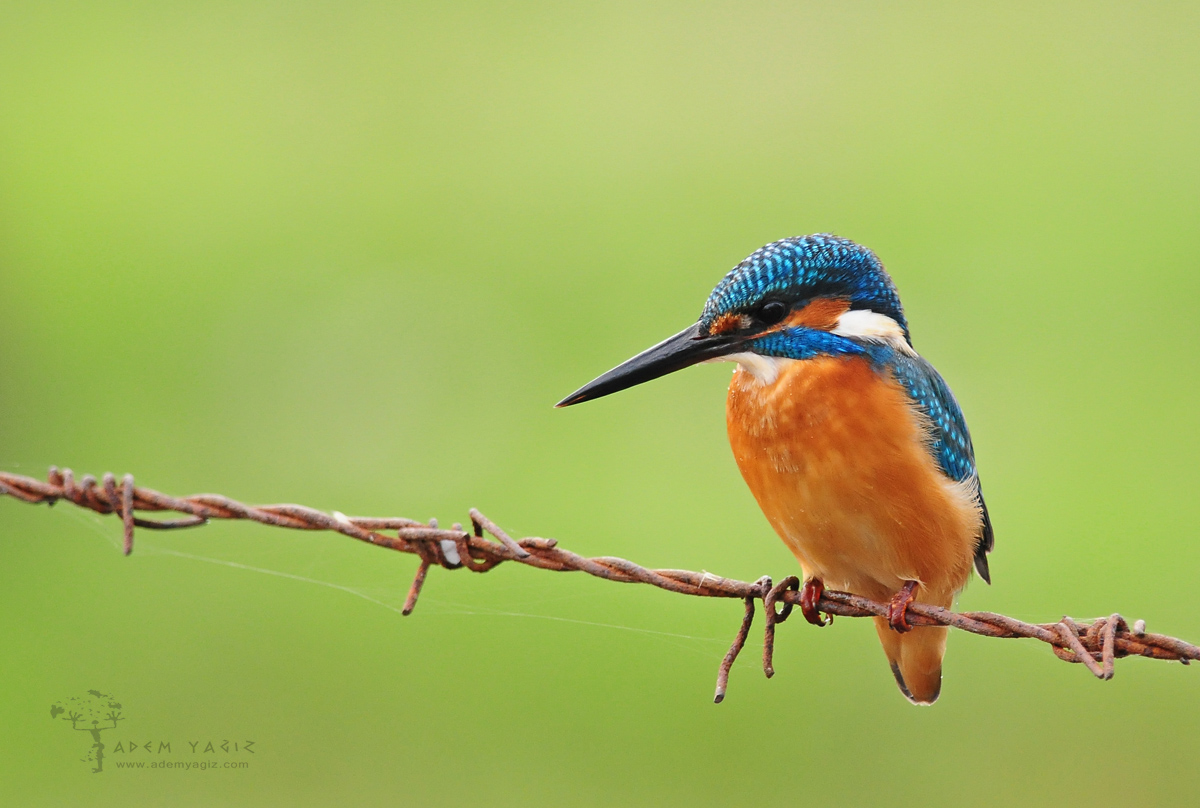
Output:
[726, 357, 980, 605]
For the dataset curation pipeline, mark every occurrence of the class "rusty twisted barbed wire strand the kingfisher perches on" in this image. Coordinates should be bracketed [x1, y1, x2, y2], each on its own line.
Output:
[0, 466, 1200, 702]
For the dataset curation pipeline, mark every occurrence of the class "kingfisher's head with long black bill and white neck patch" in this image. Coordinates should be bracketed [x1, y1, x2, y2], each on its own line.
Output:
[557, 233, 911, 407]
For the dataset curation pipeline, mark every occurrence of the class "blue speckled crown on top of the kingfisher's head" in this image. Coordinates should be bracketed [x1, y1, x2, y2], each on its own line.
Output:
[700, 233, 911, 342]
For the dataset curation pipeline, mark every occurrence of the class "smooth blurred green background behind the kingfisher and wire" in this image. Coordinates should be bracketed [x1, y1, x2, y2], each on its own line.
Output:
[0, 2, 1200, 806]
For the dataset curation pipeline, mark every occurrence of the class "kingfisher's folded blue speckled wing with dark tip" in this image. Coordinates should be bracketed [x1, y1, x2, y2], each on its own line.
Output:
[887, 352, 995, 583]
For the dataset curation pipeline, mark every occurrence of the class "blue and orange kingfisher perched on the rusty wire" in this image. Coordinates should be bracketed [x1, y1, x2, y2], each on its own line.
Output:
[557, 233, 994, 705]
